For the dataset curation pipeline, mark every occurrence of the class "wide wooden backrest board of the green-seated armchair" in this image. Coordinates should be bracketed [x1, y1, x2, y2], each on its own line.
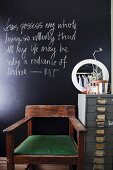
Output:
[25, 105, 75, 117]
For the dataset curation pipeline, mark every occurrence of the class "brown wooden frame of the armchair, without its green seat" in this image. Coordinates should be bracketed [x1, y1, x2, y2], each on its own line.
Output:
[4, 105, 86, 170]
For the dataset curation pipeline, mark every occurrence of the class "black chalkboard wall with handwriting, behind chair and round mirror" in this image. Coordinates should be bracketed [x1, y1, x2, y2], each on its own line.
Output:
[0, 0, 111, 156]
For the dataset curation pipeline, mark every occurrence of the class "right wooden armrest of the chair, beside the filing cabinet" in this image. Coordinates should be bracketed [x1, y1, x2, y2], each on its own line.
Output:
[69, 117, 87, 132]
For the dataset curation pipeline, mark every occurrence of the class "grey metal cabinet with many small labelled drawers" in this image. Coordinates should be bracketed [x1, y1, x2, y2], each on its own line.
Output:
[78, 94, 113, 170]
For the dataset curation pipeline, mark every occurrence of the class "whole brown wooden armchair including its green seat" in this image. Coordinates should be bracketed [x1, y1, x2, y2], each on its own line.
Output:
[4, 105, 86, 170]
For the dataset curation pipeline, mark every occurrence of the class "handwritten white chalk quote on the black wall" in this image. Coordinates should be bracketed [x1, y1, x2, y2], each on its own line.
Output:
[3, 18, 77, 78]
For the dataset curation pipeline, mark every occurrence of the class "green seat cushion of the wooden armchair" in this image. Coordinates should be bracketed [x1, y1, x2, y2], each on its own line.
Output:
[14, 135, 77, 155]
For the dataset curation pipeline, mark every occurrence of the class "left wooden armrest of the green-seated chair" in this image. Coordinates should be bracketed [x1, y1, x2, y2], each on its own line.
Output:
[3, 117, 32, 133]
